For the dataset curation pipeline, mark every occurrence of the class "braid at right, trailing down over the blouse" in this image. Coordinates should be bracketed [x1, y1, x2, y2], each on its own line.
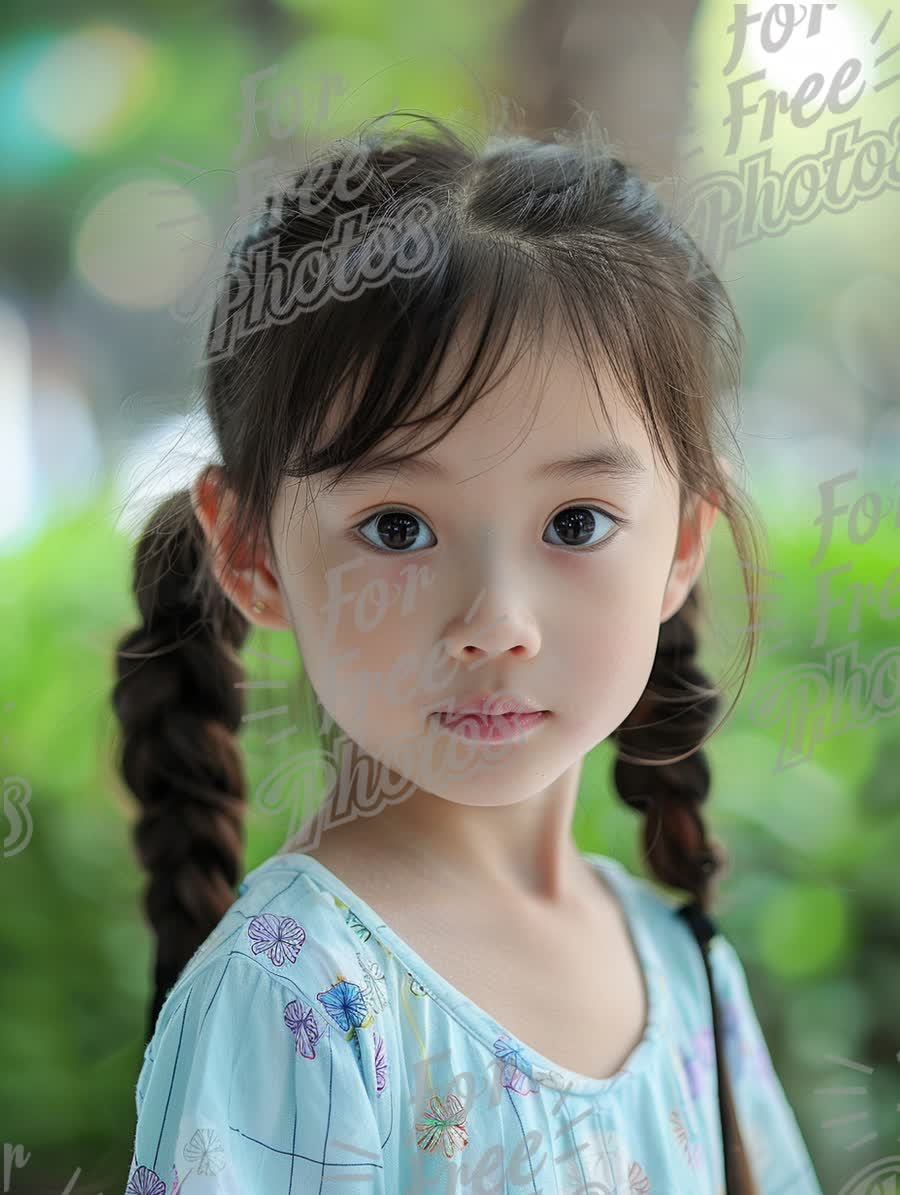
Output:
[613, 583, 759, 1195]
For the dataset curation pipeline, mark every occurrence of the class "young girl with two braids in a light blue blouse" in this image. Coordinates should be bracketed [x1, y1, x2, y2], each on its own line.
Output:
[114, 118, 821, 1195]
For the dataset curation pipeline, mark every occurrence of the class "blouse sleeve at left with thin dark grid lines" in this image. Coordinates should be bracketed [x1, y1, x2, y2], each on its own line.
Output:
[125, 952, 386, 1195]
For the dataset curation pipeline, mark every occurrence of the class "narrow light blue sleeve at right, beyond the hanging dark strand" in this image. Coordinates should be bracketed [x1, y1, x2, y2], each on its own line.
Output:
[712, 937, 822, 1195]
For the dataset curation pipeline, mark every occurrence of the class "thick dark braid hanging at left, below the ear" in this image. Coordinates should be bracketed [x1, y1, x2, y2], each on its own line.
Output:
[112, 490, 250, 1038]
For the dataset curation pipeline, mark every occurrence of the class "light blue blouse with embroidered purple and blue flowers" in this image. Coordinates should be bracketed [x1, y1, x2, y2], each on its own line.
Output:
[127, 853, 822, 1195]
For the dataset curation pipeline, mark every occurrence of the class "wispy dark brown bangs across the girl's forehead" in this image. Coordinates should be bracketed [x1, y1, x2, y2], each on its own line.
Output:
[270, 227, 693, 492]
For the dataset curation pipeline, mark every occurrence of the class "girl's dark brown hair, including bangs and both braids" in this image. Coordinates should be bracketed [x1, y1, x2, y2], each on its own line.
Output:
[112, 114, 759, 1195]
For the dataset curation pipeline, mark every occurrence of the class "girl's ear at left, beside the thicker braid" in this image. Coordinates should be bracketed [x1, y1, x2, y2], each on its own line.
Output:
[190, 465, 292, 631]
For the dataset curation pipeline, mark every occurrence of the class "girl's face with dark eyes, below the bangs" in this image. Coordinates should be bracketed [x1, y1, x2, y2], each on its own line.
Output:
[253, 332, 715, 822]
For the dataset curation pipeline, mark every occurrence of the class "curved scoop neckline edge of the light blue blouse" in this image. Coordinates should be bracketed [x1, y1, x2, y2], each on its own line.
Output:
[239, 851, 665, 1095]
